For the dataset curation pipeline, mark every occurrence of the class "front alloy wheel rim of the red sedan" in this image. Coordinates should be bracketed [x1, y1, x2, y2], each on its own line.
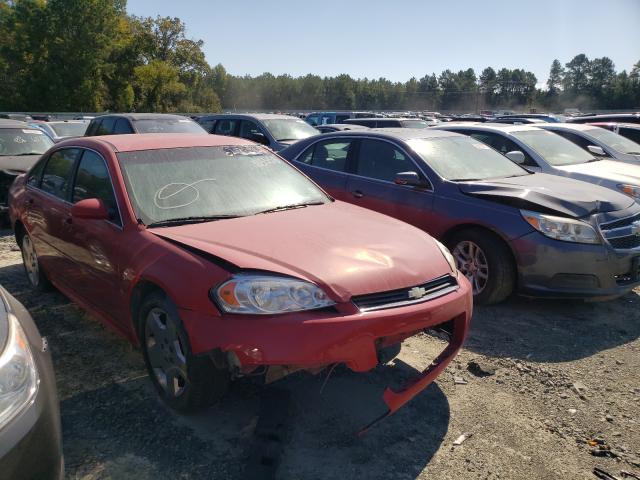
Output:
[145, 307, 188, 397]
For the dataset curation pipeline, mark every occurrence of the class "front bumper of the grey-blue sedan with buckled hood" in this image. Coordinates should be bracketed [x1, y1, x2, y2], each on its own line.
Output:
[512, 232, 640, 300]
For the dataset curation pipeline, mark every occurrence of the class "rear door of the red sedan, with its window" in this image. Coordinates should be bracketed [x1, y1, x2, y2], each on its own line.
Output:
[25, 148, 79, 285]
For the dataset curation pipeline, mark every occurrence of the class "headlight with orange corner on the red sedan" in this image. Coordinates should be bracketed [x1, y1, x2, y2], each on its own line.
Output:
[212, 275, 334, 315]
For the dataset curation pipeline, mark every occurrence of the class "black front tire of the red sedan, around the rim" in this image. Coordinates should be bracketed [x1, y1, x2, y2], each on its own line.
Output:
[138, 292, 230, 413]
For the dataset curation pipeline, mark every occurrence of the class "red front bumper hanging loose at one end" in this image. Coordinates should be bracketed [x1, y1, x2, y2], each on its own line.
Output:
[180, 275, 473, 422]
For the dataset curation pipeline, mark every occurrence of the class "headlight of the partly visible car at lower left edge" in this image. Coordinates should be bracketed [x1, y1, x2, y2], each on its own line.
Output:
[0, 314, 38, 428]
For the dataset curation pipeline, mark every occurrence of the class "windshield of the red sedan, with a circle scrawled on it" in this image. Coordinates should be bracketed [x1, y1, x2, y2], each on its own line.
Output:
[118, 145, 330, 225]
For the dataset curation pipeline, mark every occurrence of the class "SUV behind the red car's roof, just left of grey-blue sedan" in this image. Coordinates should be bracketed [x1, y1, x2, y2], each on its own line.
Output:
[192, 113, 318, 152]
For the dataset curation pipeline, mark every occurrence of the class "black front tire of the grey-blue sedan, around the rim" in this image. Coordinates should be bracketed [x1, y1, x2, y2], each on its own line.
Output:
[447, 229, 516, 305]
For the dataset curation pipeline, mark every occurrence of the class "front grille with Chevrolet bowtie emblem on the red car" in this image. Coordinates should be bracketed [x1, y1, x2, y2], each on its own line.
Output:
[351, 275, 458, 312]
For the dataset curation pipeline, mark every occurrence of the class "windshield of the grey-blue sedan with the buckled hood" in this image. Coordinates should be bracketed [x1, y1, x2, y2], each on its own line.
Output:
[407, 136, 529, 182]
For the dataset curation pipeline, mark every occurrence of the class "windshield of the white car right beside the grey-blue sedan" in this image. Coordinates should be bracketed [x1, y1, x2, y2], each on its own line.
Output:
[512, 130, 594, 167]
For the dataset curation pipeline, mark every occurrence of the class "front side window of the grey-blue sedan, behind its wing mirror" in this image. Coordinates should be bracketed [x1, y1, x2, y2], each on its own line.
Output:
[356, 140, 416, 182]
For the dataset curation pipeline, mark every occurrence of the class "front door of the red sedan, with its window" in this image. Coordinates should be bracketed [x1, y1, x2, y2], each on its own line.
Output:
[64, 150, 128, 327]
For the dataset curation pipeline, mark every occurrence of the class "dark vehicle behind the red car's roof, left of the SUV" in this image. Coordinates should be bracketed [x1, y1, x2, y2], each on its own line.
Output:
[85, 113, 206, 137]
